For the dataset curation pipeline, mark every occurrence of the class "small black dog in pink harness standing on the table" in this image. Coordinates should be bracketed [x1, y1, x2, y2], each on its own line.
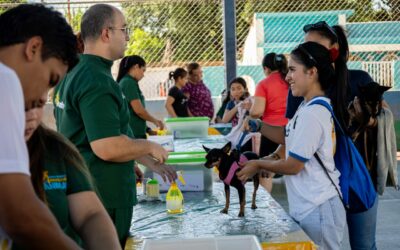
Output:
[203, 142, 260, 217]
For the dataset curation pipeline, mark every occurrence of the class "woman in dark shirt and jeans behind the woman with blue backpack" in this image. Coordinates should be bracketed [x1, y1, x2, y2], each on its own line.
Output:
[302, 21, 380, 250]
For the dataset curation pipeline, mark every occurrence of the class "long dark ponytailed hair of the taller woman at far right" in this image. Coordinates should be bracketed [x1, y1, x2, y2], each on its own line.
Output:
[303, 22, 350, 129]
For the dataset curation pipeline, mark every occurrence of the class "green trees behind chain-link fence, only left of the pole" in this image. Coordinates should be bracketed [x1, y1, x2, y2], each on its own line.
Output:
[123, 0, 223, 64]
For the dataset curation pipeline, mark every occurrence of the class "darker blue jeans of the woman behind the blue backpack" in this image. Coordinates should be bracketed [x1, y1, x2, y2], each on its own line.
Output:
[347, 195, 379, 250]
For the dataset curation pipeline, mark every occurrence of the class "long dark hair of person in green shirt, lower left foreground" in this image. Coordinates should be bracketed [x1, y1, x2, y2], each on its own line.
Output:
[27, 125, 94, 202]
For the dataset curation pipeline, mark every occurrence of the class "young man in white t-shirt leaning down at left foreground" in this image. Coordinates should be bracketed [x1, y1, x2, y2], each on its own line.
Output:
[0, 4, 78, 249]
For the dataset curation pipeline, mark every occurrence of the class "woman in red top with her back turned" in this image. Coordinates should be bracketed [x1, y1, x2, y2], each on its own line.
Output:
[250, 53, 289, 191]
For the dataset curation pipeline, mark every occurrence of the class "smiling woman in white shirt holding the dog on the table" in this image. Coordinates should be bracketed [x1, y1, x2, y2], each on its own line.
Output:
[237, 42, 346, 249]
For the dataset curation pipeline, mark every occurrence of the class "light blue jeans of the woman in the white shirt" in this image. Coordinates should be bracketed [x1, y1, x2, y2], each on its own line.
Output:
[299, 196, 346, 250]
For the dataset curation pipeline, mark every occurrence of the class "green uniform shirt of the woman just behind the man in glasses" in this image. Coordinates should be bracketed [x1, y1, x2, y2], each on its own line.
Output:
[119, 74, 147, 138]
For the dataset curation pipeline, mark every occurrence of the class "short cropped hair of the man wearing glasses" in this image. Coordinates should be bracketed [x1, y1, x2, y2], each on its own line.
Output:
[81, 4, 117, 41]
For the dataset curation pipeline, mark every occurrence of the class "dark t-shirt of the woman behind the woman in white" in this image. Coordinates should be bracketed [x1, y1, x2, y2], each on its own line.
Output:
[286, 69, 373, 119]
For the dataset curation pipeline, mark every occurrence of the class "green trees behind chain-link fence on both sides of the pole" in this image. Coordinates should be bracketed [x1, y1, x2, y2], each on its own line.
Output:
[122, 0, 382, 65]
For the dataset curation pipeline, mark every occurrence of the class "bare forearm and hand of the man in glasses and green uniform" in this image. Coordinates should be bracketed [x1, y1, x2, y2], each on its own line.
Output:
[90, 135, 168, 163]
